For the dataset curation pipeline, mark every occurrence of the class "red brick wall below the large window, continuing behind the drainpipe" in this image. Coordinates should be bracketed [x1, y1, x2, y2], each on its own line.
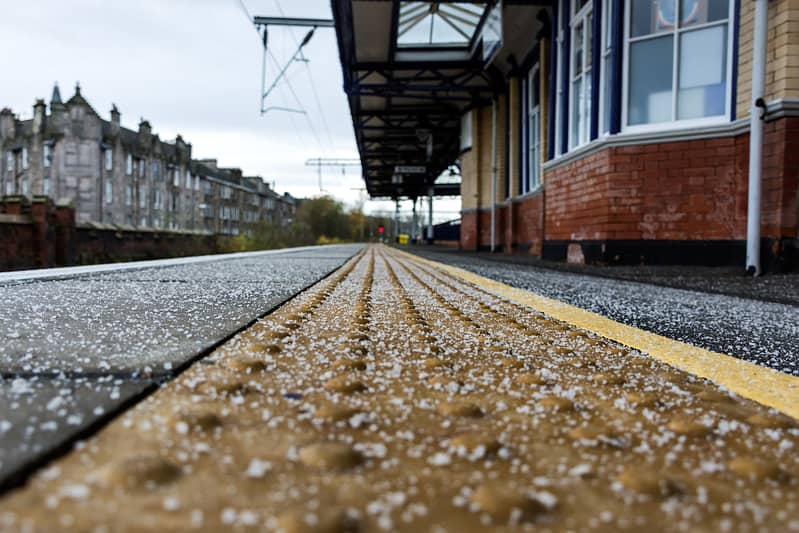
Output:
[545, 118, 799, 241]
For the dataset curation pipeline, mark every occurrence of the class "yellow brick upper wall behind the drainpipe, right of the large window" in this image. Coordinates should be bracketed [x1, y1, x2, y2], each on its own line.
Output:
[735, 0, 799, 118]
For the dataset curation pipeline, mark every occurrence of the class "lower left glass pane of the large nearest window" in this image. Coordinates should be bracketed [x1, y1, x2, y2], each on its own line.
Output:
[627, 35, 674, 125]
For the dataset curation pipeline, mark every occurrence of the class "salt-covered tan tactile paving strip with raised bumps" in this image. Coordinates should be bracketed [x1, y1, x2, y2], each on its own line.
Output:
[0, 247, 799, 533]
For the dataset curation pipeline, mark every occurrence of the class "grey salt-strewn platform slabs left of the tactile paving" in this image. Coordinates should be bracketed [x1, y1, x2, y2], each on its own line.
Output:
[0, 245, 361, 488]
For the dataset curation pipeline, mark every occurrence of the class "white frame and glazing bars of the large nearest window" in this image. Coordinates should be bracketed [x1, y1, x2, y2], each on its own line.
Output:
[621, 0, 735, 133]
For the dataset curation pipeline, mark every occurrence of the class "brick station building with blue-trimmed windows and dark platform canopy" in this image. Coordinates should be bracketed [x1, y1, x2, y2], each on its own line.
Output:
[333, 0, 799, 268]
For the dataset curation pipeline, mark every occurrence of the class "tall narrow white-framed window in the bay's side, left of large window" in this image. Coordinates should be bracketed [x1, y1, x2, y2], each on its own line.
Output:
[569, 0, 594, 148]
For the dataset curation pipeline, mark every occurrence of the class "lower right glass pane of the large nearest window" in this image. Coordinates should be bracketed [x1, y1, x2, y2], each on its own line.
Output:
[677, 24, 727, 119]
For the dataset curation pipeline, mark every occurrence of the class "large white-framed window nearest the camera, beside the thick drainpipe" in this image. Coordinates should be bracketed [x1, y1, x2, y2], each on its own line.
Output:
[625, 0, 732, 126]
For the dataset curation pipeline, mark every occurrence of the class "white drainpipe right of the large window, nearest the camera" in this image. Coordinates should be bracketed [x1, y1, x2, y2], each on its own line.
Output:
[746, 0, 768, 276]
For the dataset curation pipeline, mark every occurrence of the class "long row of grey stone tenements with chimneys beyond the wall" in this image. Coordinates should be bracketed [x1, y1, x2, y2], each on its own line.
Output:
[0, 86, 295, 235]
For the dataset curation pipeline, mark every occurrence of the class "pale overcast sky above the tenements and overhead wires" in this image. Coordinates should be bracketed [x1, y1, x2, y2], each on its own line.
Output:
[0, 0, 459, 219]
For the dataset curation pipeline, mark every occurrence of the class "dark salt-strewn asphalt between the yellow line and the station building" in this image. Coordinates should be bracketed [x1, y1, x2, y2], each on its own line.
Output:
[407, 248, 799, 376]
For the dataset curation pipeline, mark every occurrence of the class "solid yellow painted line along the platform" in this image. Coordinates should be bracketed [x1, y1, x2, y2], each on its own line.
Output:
[399, 251, 799, 419]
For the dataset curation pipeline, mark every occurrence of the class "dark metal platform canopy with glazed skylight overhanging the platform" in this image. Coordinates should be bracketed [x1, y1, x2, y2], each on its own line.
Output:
[332, 0, 548, 198]
